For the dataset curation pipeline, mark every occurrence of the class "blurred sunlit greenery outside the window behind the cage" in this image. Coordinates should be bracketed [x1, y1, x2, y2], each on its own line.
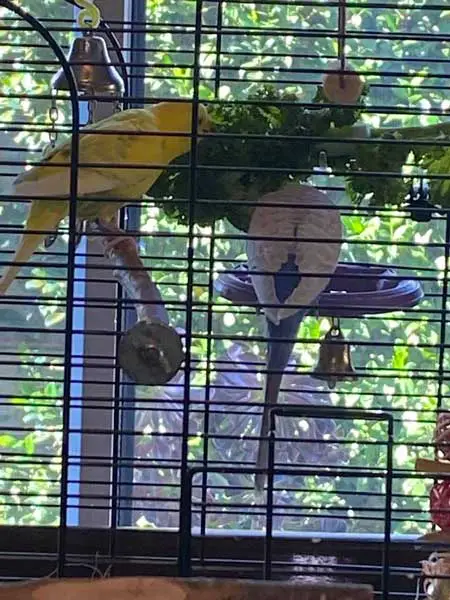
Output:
[0, 0, 450, 534]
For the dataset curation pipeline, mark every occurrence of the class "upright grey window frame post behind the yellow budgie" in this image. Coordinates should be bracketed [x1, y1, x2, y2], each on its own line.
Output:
[78, 0, 137, 527]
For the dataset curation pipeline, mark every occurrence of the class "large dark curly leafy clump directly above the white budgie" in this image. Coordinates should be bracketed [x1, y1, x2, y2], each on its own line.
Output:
[148, 85, 368, 230]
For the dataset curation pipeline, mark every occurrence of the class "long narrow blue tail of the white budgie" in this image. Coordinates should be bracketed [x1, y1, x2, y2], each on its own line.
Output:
[255, 310, 307, 491]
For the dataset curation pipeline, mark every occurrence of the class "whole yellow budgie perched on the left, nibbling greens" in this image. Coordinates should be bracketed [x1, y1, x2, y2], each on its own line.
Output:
[0, 101, 211, 296]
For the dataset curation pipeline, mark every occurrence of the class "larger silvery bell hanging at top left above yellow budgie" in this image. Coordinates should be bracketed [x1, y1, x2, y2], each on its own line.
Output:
[51, 32, 125, 97]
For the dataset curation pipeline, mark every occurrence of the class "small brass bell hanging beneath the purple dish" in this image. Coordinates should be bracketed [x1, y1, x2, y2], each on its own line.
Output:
[312, 320, 358, 389]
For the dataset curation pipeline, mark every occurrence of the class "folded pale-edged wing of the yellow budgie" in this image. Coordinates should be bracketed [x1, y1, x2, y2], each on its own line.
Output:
[13, 109, 163, 198]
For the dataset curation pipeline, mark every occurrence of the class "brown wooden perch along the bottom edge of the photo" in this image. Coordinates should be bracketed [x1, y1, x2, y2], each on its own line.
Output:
[0, 577, 373, 600]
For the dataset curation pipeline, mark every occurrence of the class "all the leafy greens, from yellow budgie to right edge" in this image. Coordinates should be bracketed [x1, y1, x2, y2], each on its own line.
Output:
[148, 85, 450, 231]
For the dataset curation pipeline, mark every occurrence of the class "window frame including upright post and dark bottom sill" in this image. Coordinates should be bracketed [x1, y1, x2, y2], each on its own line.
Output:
[0, 0, 442, 577]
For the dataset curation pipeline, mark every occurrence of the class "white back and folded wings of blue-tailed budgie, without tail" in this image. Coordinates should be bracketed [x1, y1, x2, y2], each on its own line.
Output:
[247, 184, 342, 324]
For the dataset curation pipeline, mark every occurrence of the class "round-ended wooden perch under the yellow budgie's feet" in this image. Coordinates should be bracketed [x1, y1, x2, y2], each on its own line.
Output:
[87, 221, 184, 385]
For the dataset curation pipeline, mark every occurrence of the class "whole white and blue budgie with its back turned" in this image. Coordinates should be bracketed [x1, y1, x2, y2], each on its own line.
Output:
[247, 183, 342, 490]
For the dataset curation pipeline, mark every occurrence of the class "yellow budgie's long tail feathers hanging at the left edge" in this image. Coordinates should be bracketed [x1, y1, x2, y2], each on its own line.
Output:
[0, 201, 66, 296]
